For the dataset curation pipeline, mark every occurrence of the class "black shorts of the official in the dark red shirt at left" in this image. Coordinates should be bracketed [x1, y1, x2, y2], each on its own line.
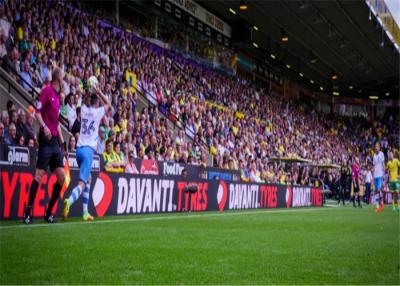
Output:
[36, 131, 64, 172]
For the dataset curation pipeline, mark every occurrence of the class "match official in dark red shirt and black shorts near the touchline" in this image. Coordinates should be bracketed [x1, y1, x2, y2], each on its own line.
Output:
[23, 67, 65, 224]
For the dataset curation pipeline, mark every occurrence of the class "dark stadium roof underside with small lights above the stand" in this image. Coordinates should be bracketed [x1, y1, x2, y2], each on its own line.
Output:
[198, 0, 399, 99]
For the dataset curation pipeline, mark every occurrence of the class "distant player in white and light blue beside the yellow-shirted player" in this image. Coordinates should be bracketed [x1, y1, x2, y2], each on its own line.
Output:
[373, 142, 385, 212]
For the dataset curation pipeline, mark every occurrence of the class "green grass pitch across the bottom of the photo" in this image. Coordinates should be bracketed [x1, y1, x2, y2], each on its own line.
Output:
[0, 207, 400, 285]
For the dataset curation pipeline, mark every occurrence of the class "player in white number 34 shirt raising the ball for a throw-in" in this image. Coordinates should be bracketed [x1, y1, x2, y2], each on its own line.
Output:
[64, 87, 111, 221]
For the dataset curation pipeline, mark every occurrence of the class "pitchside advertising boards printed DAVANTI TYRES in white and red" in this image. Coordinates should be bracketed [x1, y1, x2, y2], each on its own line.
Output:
[0, 145, 322, 220]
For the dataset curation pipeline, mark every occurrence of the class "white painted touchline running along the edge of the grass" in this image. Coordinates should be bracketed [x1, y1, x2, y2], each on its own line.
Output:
[0, 208, 333, 230]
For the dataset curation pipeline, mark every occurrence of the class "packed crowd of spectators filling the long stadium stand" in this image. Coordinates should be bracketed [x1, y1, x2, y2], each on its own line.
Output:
[0, 1, 399, 184]
